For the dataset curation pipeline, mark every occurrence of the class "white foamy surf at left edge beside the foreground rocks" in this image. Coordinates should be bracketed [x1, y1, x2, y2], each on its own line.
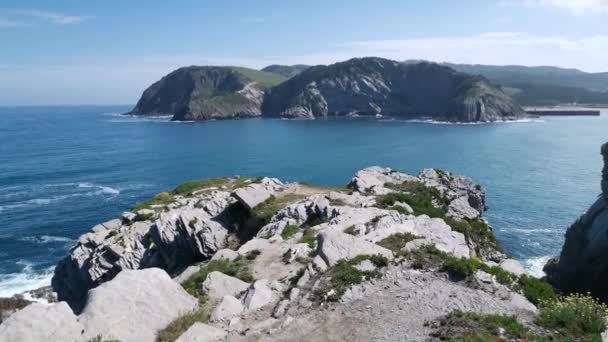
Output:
[0, 260, 55, 297]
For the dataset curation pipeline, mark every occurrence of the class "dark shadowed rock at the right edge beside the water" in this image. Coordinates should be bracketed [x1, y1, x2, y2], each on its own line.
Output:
[544, 143, 608, 301]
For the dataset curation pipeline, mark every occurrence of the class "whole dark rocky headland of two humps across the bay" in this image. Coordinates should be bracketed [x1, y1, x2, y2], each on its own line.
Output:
[130, 57, 525, 122]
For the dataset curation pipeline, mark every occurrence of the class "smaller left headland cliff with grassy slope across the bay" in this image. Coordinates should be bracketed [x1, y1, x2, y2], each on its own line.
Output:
[129, 66, 284, 121]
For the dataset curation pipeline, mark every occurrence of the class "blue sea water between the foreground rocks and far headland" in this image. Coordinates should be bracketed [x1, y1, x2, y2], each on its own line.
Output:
[0, 106, 608, 297]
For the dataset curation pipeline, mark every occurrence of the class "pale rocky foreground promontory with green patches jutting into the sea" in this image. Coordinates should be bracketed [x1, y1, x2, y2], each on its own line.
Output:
[0, 167, 599, 342]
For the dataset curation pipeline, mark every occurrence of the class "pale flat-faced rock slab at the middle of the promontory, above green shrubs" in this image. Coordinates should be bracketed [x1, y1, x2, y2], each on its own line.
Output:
[317, 230, 393, 266]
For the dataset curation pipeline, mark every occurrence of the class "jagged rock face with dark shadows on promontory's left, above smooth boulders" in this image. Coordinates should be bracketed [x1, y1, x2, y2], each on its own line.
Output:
[52, 178, 281, 312]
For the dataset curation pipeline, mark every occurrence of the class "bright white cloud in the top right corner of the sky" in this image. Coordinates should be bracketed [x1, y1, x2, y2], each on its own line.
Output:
[498, 0, 608, 15]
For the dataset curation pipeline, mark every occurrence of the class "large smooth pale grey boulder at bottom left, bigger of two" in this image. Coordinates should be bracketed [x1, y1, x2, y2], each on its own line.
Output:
[79, 268, 198, 342]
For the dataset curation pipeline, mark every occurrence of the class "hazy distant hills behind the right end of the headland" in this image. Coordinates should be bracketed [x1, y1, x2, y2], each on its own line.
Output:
[444, 63, 608, 105]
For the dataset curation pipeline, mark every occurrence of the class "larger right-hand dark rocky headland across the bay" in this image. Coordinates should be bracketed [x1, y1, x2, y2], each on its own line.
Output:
[262, 58, 524, 122]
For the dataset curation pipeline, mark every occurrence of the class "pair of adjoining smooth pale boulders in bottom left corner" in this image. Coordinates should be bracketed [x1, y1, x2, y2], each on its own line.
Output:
[0, 268, 198, 342]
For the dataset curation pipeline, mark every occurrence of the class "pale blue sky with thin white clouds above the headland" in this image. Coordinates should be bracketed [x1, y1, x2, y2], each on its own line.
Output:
[0, 0, 608, 106]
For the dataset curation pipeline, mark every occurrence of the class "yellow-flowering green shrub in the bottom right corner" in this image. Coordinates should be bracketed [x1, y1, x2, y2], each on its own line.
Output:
[536, 294, 608, 341]
